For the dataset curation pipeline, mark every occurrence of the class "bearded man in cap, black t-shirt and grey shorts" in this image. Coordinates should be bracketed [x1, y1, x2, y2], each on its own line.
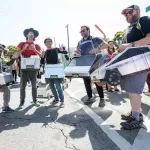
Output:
[119, 5, 150, 130]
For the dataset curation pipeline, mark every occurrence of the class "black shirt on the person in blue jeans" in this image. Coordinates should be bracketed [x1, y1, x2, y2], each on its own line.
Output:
[45, 48, 68, 64]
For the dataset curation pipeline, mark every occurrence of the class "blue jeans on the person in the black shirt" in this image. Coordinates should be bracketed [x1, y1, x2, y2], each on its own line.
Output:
[49, 79, 64, 102]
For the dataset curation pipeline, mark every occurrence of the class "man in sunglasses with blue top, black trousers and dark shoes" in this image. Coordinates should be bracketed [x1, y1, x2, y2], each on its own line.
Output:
[75, 26, 108, 107]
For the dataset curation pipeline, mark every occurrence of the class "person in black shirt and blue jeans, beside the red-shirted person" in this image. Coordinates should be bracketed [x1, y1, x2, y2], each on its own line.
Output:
[42, 38, 68, 107]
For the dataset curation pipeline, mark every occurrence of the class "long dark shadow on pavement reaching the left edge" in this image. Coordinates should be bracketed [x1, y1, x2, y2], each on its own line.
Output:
[0, 105, 59, 133]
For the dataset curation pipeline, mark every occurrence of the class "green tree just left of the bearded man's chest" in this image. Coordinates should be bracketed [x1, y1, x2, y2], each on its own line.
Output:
[113, 30, 126, 49]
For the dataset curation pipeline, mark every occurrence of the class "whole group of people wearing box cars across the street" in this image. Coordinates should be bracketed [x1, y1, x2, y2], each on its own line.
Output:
[0, 5, 150, 130]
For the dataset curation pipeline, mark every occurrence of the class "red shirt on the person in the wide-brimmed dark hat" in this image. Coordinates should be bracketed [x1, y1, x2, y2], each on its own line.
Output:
[17, 42, 41, 56]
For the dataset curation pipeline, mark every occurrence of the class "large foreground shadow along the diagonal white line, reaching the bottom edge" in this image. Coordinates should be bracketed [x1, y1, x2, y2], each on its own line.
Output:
[57, 109, 119, 150]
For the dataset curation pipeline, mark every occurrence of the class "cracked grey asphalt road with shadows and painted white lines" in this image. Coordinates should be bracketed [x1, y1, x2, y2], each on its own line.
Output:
[0, 79, 150, 150]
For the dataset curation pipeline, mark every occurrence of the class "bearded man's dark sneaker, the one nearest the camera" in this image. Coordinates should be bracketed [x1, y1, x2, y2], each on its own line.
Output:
[120, 116, 143, 130]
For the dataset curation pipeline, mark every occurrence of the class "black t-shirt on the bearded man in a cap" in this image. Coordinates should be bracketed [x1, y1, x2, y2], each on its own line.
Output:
[122, 16, 150, 43]
